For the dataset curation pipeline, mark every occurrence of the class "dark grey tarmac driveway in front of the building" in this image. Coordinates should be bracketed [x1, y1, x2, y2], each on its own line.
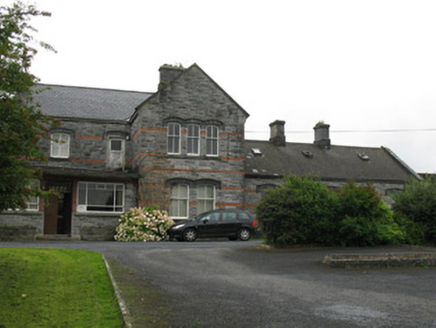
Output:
[0, 241, 436, 327]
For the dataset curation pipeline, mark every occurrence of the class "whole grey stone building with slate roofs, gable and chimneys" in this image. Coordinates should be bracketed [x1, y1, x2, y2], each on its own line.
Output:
[0, 64, 416, 240]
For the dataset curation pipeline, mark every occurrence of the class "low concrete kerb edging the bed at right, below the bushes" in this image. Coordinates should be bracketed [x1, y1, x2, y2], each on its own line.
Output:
[323, 252, 436, 269]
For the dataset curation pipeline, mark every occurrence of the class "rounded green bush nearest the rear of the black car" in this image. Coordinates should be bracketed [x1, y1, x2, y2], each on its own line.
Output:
[256, 176, 336, 246]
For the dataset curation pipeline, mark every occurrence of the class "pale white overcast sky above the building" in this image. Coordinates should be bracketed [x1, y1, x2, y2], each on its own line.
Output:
[9, 0, 436, 173]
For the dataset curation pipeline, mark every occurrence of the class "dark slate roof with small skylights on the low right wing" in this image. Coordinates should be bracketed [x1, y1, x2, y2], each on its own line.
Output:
[244, 140, 417, 182]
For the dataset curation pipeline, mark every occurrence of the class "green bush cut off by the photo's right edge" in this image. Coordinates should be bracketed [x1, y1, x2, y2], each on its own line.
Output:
[393, 178, 436, 244]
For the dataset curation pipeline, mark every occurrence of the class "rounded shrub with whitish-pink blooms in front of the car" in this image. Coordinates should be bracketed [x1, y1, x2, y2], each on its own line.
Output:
[115, 206, 174, 241]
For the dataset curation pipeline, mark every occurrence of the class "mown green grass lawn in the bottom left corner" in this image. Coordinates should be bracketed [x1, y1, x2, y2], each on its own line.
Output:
[0, 248, 123, 328]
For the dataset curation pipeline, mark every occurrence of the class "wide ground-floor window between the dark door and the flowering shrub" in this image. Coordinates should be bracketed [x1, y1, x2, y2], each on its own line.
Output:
[77, 182, 124, 213]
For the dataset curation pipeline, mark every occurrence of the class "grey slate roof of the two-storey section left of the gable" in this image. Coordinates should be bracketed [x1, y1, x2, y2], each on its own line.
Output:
[34, 84, 153, 120]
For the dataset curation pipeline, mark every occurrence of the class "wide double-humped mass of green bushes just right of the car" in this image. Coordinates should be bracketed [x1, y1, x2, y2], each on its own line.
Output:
[256, 176, 406, 247]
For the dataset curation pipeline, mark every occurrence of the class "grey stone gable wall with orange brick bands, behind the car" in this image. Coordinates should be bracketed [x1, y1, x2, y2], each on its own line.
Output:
[132, 66, 247, 216]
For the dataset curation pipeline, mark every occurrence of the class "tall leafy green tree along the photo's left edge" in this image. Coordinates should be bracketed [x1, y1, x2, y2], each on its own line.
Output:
[0, 2, 54, 211]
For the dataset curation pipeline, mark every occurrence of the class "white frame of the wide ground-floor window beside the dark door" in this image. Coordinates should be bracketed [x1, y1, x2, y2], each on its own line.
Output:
[77, 181, 126, 213]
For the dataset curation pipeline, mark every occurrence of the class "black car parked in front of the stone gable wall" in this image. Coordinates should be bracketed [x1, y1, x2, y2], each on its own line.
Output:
[167, 209, 256, 241]
